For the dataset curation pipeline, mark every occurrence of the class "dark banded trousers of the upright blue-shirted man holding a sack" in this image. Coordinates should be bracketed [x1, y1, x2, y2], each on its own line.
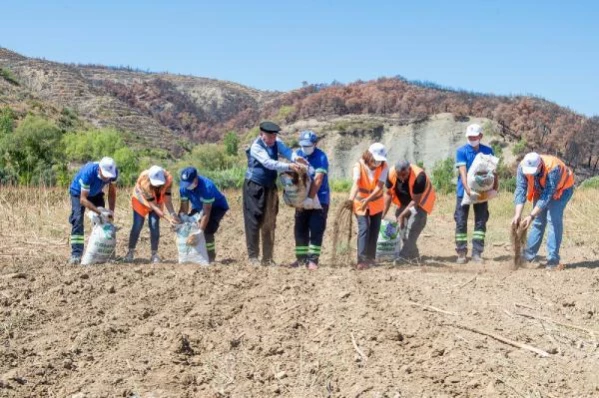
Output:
[454, 197, 489, 254]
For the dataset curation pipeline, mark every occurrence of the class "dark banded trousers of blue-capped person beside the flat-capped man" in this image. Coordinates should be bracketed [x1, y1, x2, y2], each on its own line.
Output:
[294, 205, 329, 264]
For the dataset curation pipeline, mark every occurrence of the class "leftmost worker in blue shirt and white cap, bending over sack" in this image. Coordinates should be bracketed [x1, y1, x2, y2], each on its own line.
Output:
[69, 157, 119, 264]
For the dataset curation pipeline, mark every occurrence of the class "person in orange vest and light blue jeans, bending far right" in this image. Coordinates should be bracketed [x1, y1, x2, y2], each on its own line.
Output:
[512, 152, 574, 269]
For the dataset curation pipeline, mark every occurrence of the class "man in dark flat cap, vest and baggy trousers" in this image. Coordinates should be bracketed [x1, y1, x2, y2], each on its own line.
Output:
[243, 121, 307, 265]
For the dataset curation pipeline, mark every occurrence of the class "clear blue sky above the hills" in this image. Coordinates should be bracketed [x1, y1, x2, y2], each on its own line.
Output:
[0, 0, 599, 115]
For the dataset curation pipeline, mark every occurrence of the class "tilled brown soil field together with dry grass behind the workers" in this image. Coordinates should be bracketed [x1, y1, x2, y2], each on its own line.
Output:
[0, 188, 599, 398]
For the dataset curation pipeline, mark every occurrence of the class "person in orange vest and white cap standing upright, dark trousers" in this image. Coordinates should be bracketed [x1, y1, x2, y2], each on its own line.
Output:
[349, 142, 389, 270]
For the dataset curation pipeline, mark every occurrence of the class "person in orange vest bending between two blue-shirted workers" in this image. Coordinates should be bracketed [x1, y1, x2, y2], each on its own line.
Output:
[125, 166, 180, 263]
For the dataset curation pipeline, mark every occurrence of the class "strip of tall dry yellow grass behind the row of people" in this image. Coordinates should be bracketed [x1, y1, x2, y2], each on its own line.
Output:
[0, 187, 599, 264]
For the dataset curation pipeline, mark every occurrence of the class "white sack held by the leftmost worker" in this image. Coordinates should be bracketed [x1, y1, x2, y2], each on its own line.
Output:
[81, 207, 116, 265]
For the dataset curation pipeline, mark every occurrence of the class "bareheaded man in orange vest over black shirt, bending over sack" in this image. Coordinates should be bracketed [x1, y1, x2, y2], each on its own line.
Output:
[383, 160, 437, 260]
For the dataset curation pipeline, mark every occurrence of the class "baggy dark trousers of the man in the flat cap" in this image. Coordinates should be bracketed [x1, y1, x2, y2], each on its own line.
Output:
[243, 180, 279, 261]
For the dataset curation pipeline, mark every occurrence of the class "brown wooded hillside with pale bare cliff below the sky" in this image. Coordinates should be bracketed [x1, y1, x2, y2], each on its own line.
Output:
[0, 48, 599, 178]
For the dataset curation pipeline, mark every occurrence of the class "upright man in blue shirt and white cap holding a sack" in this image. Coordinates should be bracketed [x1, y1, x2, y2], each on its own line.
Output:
[454, 124, 498, 264]
